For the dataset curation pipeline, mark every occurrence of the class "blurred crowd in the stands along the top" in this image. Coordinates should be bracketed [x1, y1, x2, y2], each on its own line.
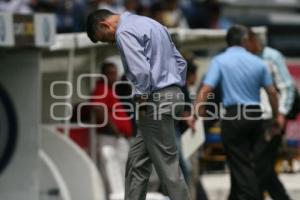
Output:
[0, 0, 232, 33]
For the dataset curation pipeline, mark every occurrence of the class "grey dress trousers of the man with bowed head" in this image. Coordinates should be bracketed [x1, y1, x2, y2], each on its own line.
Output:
[125, 86, 190, 200]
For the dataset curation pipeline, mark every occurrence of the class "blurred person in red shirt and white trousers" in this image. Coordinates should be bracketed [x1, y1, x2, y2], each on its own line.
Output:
[91, 63, 133, 194]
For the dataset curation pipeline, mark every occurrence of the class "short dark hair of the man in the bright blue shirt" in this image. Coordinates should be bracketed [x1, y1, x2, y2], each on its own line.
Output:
[226, 24, 248, 46]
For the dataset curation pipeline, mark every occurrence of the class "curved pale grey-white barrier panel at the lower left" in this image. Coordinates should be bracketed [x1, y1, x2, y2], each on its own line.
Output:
[41, 127, 106, 200]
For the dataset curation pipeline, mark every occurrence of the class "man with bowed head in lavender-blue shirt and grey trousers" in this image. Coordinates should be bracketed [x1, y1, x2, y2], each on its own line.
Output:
[87, 10, 190, 200]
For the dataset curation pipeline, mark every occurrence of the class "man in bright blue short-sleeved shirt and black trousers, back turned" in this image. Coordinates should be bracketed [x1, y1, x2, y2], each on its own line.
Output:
[195, 25, 280, 200]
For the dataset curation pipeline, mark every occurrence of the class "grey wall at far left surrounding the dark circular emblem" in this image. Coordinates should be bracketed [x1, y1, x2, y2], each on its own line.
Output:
[0, 49, 40, 200]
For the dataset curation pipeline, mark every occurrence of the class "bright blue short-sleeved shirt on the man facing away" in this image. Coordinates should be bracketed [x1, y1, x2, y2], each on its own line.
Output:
[204, 46, 273, 107]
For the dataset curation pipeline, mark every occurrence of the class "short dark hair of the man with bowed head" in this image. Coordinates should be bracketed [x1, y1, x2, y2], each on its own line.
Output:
[86, 9, 115, 43]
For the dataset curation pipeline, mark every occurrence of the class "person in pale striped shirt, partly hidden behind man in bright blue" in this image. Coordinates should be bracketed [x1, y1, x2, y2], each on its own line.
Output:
[246, 29, 295, 200]
